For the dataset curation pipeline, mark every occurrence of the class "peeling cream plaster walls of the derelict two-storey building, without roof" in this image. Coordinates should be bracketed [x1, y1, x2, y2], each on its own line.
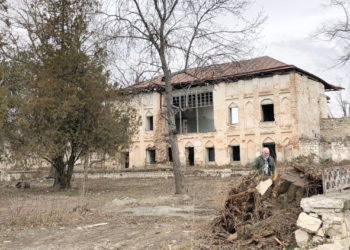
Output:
[130, 72, 326, 168]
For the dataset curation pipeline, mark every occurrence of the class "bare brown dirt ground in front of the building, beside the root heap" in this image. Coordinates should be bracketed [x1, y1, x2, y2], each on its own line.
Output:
[0, 176, 242, 250]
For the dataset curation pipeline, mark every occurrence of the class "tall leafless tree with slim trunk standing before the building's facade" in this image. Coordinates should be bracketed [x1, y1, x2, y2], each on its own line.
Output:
[101, 0, 266, 194]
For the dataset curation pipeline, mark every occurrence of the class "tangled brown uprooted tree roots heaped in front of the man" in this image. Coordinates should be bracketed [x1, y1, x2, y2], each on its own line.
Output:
[212, 174, 301, 250]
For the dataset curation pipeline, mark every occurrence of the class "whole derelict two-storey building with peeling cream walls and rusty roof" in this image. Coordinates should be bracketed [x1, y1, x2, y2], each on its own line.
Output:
[128, 56, 339, 168]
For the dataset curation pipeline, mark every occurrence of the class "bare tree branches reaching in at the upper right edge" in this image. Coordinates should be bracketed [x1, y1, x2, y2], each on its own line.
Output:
[311, 0, 350, 67]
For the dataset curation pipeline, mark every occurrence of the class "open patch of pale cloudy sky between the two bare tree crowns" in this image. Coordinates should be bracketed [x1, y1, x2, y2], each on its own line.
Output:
[247, 0, 350, 116]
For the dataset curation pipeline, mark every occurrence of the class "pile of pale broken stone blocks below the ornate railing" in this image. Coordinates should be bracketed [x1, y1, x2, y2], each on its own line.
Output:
[295, 194, 350, 250]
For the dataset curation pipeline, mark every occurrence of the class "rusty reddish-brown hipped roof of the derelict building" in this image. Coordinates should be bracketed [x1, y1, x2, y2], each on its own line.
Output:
[132, 56, 341, 90]
